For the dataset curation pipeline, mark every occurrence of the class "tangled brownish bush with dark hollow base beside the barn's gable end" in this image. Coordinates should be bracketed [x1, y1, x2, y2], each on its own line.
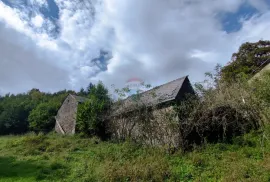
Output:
[177, 80, 264, 150]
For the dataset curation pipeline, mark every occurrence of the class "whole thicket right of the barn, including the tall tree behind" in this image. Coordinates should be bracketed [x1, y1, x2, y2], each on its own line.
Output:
[176, 41, 270, 149]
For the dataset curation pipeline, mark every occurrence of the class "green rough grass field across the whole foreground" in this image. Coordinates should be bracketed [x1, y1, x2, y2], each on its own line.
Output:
[0, 130, 270, 182]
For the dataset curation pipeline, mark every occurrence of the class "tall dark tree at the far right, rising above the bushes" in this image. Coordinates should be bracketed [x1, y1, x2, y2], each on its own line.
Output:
[221, 41, 270, 83]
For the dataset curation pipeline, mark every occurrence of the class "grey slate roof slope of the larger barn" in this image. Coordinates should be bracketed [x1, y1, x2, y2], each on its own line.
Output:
[113, 76, 188, 115]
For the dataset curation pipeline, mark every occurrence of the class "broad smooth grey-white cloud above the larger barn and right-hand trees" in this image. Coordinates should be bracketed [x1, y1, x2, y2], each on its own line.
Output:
[90, 0, 269, 85]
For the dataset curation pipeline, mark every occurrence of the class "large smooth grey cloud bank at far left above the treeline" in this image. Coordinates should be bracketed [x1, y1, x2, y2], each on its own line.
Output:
[0, 23, 70, 93]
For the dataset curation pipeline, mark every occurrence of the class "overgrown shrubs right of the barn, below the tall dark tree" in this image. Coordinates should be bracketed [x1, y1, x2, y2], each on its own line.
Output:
[176, 65, 270, 149]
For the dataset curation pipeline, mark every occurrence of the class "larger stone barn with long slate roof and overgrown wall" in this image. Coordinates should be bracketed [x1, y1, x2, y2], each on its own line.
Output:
[108, 76, 195, 147]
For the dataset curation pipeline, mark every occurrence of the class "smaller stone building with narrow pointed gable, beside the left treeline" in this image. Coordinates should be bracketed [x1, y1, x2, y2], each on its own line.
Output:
[55, 94, 87, 135]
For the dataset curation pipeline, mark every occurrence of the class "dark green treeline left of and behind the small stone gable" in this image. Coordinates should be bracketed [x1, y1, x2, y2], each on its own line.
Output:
[0, 83, 95, 135]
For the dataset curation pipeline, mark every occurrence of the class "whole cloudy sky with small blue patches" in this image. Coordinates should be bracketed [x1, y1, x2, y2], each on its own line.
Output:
[0, 0, 270, 94]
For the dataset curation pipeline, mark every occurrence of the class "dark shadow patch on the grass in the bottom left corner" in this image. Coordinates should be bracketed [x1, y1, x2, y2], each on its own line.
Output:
[0, 157, 68, 180]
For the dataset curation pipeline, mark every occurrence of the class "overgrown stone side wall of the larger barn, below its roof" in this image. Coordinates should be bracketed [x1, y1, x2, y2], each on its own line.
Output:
[109, 106, 180, 148]
